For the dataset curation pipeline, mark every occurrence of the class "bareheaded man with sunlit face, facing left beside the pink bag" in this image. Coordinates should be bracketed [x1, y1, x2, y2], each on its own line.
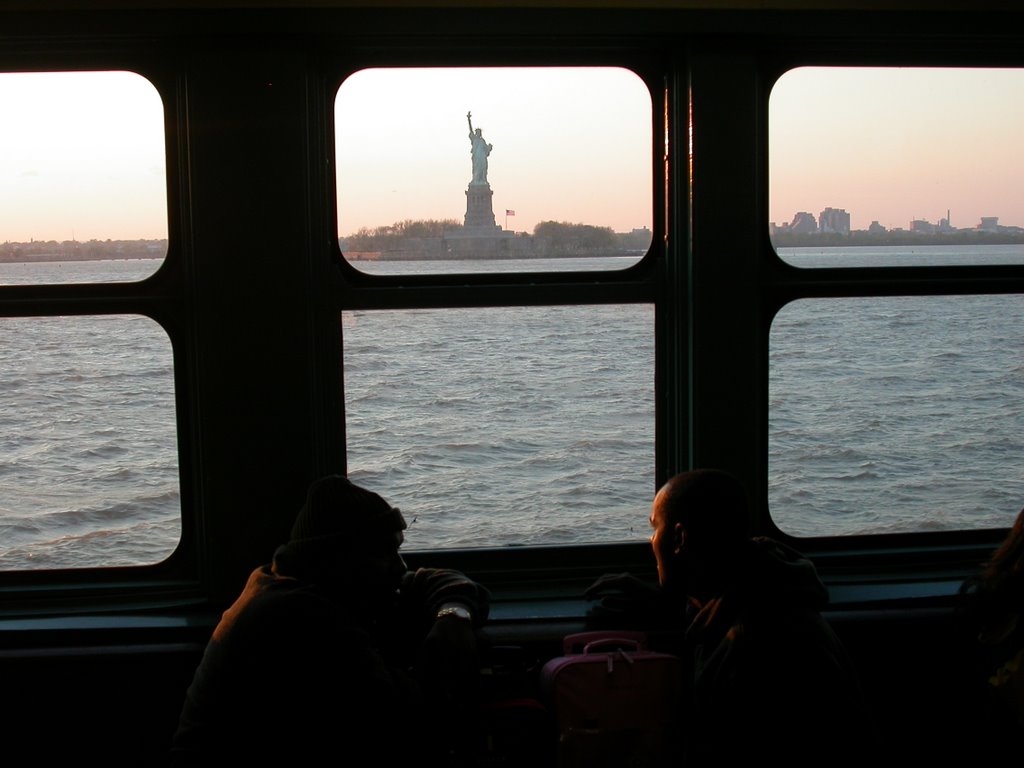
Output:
[587, 470, 878, 768]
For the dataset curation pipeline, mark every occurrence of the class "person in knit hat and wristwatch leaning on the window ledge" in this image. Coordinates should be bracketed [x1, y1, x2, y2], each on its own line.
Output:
[170, 475, 489, 766]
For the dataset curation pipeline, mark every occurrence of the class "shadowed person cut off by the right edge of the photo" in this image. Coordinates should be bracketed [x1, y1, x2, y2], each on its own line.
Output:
[961, 510, 1024, 743]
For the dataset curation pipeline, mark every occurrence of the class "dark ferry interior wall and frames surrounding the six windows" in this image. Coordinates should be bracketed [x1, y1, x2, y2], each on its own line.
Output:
[0, 0, 1024, 765]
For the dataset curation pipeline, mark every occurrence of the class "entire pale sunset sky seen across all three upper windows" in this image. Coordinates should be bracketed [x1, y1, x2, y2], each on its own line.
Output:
[0, 68, 1024, 242]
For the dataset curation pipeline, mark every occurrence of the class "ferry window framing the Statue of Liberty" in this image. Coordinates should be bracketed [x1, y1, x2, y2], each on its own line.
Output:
[335, 68, 653, 273]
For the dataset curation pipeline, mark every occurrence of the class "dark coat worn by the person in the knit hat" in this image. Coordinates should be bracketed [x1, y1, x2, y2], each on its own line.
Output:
[171, 561, 487, 766]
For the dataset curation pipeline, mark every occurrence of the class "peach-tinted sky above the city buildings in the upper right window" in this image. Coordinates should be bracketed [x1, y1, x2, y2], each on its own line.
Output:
[768, 68, 1024, 229]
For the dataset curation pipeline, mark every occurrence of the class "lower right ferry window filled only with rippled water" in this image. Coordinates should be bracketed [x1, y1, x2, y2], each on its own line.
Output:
[768, 295, 1024, 537]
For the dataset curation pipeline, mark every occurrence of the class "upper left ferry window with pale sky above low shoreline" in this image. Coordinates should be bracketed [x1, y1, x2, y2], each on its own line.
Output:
[0, 72, 167, 282]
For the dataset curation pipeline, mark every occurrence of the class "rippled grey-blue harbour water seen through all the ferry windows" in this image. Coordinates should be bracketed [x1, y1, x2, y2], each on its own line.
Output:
[0, 247, 1024, 569]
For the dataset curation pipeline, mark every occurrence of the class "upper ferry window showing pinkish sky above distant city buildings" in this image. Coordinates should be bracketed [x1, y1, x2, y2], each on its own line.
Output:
[768, 67, 1024, 267]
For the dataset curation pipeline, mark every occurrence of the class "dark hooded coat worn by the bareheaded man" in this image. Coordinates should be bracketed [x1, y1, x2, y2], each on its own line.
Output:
[684, 538, 877, 768]
